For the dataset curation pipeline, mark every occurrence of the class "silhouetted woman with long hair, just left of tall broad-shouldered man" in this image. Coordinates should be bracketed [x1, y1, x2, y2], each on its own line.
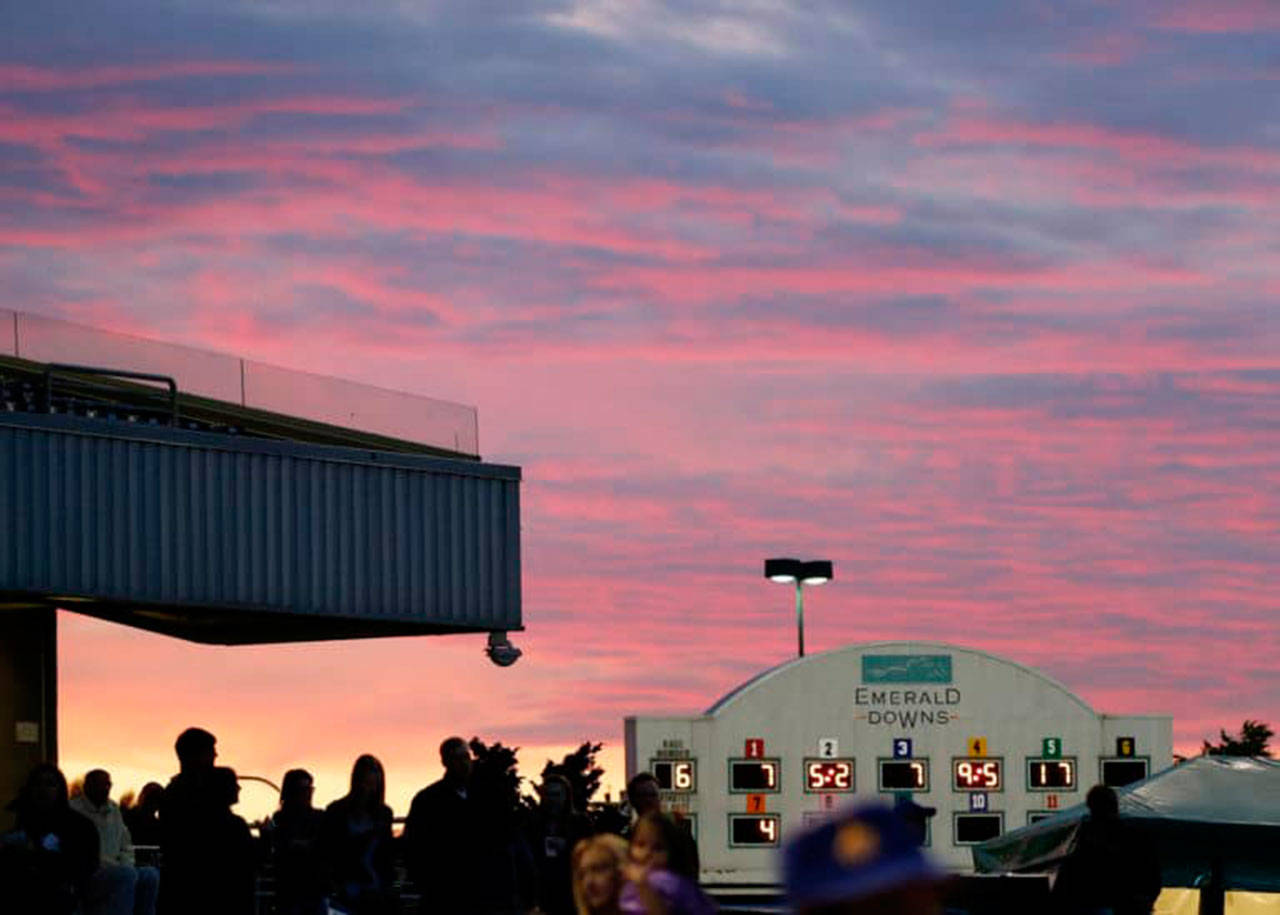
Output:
[320, 754, 396, 915]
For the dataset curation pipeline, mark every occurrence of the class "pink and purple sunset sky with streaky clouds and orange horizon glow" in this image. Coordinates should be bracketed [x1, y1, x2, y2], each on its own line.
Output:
[0, 0, 1280, 813]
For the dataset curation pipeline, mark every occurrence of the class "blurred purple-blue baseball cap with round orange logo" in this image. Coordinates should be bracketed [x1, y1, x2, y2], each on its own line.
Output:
[782, 804, 943, 907]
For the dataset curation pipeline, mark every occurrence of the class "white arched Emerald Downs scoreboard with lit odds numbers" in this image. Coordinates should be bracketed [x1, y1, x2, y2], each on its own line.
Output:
[626, 641, 1172, 884]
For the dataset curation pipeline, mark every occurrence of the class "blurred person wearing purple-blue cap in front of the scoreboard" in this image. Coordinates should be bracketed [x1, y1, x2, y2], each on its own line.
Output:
[782, 804, 945, 915]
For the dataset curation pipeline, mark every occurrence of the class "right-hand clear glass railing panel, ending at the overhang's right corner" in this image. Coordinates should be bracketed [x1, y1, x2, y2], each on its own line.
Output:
[244, 360, 480, 456]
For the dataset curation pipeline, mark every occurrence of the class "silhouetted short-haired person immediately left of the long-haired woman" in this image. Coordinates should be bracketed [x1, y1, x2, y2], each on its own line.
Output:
[265, 769, 329, 915]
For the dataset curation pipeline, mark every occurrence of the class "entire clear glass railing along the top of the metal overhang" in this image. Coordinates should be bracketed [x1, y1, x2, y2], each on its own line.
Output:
[0, 311, 480, 457]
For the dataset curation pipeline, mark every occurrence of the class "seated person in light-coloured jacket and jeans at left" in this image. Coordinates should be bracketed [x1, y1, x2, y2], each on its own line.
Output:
[70, 769, 160, 915]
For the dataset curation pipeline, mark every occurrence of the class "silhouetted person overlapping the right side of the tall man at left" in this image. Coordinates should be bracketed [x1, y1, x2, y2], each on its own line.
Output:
[202, 765, 257, 915]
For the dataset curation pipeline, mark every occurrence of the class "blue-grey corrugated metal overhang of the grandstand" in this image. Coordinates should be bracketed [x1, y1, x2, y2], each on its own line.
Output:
[0, 413, 522, 644]
